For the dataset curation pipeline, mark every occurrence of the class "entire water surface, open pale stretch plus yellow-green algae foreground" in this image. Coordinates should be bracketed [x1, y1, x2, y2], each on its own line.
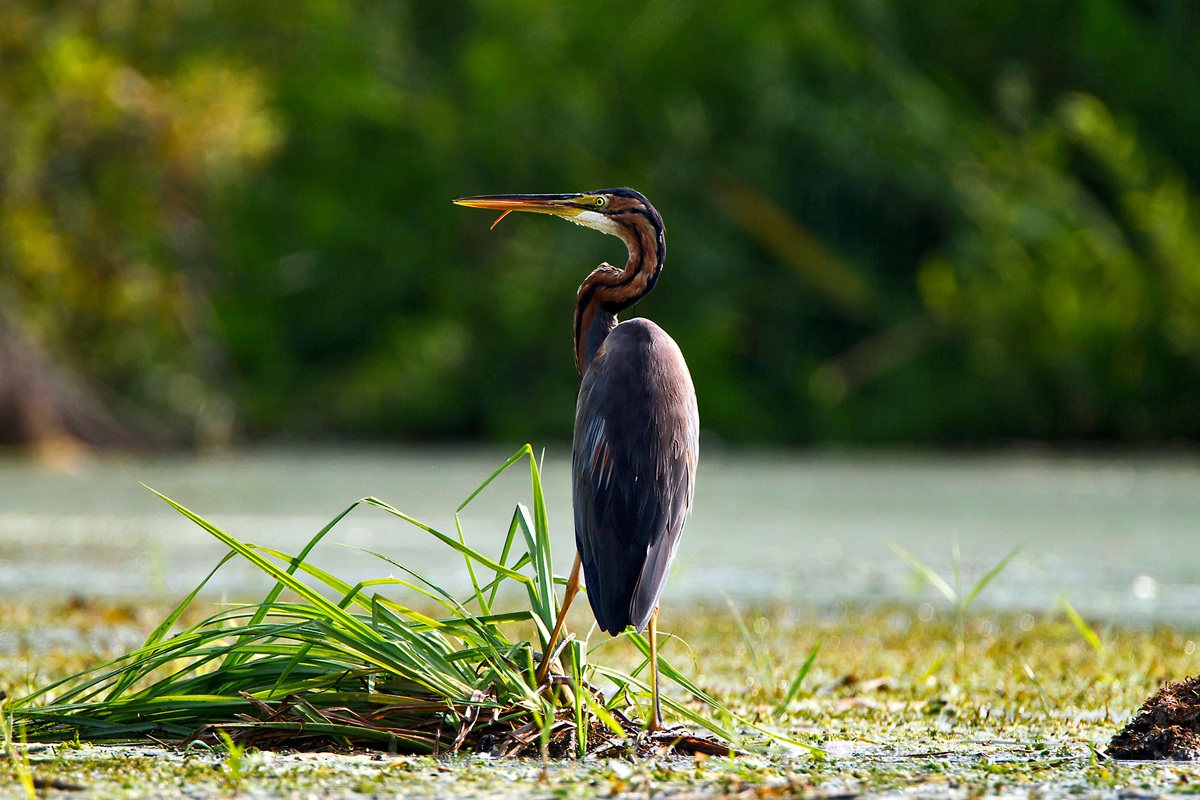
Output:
[0, 451, 1200, 800]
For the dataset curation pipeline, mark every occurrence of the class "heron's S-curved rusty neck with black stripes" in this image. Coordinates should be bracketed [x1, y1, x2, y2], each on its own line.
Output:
[575, 209, 666, 377]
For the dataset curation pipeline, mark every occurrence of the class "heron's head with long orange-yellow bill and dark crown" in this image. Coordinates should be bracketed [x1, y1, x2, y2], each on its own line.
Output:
[455, 188, 662, 240]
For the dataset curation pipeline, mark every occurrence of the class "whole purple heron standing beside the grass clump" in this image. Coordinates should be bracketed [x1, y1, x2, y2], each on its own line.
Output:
[455, 188, 700, 730]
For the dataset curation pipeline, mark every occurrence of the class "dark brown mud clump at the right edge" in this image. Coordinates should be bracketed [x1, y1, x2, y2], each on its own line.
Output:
[1109, 676, 1200, 760]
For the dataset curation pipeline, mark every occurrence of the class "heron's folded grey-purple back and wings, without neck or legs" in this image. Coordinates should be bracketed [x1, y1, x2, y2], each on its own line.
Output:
[572, 319, 700, 634]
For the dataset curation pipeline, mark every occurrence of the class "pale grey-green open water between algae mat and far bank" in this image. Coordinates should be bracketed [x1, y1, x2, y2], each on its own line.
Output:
[0, 447, 1200, 621]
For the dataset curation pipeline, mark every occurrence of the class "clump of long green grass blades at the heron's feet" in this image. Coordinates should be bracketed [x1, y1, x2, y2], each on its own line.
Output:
[10, 445, 758, 756]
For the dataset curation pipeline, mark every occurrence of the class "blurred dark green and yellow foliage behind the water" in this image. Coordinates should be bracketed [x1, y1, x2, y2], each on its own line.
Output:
[0, 0, 1200, 444]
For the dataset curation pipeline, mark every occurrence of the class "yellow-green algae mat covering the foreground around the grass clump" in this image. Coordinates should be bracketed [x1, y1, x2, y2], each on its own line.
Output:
[0, 603, 1200, 800]
